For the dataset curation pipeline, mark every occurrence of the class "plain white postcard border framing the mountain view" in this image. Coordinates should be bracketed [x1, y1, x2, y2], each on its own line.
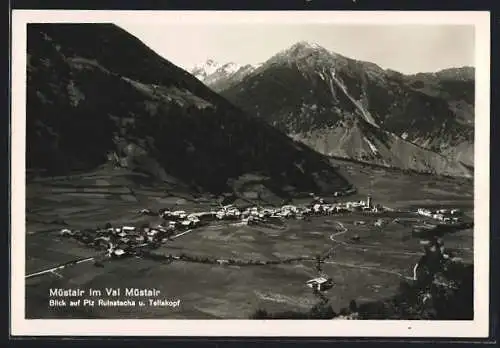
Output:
[10, 10, 490, 338]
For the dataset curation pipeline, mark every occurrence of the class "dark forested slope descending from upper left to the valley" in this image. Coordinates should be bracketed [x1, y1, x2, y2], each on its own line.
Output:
[27, 24, 348, 195]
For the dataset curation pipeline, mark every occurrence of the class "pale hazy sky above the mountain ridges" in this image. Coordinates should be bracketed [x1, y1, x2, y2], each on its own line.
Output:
[117, 23, 474, 73]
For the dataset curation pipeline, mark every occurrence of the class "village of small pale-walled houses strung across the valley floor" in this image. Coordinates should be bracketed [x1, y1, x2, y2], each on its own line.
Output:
[60, 194, 468, 266]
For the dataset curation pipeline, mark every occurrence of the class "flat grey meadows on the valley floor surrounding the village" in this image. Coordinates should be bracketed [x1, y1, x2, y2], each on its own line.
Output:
[26, 161, 473, 319]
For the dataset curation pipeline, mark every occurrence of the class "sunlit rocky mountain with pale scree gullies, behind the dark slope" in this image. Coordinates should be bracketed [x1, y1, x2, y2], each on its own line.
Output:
[221, 42, 474, 176]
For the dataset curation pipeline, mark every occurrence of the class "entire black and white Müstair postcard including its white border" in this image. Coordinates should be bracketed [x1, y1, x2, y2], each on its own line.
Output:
[11, 10, 490, 337]
